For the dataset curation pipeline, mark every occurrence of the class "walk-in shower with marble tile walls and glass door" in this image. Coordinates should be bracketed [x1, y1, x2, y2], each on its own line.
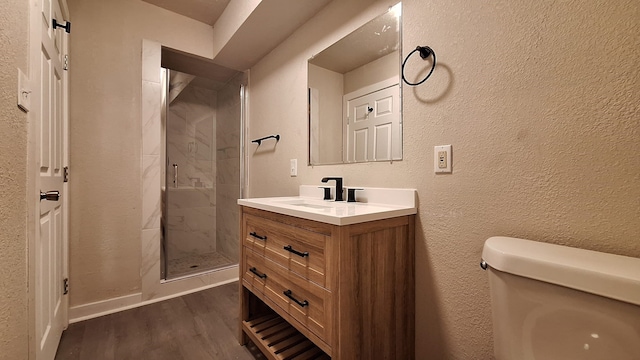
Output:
[161, 64, 245, 280]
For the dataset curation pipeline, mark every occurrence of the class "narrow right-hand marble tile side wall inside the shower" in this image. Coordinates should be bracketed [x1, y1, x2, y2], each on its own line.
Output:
[216, 74, 245, 261]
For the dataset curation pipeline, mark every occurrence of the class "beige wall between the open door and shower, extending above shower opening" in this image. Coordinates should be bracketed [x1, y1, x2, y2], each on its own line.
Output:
[68, 0, 213, 306]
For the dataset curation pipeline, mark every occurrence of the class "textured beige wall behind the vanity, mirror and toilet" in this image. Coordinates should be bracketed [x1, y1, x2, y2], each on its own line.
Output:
[248, 0, 640, 359]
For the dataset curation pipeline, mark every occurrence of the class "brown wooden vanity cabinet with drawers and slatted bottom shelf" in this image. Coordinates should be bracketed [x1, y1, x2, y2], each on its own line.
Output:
[240, 206, 415, 360]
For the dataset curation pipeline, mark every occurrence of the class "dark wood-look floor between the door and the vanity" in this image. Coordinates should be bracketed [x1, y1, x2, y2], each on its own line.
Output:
[56, 282, 264, 360]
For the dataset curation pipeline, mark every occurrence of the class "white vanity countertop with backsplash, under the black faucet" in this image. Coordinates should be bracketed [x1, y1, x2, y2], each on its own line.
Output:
[238, 185, 417, 225]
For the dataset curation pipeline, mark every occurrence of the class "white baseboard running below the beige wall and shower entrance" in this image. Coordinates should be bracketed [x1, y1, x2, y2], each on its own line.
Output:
[69, 272, 238, 324]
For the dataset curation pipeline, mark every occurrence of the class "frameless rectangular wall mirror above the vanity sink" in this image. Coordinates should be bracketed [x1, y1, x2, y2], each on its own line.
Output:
[307, 3, 402, 165]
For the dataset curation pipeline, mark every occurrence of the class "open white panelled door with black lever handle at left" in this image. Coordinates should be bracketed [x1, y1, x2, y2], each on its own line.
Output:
[29, 0, 68, 360]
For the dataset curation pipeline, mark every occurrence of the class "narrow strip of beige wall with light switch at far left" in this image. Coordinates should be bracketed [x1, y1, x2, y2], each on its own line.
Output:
[0, 0, 29, 359]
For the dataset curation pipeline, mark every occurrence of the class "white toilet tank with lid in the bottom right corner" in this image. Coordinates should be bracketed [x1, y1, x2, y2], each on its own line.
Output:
[481, 237, 640, 360]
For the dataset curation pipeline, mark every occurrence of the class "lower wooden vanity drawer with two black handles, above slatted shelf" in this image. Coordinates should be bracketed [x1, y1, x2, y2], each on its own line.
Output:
[242, 248, 331, 343]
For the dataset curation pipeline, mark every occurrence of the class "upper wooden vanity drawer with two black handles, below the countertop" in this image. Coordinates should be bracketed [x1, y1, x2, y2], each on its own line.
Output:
[243, 214, 329, 288]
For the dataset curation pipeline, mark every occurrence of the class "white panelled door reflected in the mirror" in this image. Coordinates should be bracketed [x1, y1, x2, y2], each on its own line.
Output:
[346, 84, 402, 162]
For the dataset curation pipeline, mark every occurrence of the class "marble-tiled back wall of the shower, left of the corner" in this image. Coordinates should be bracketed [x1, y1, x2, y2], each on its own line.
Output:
[165, 85, 216, 261]
